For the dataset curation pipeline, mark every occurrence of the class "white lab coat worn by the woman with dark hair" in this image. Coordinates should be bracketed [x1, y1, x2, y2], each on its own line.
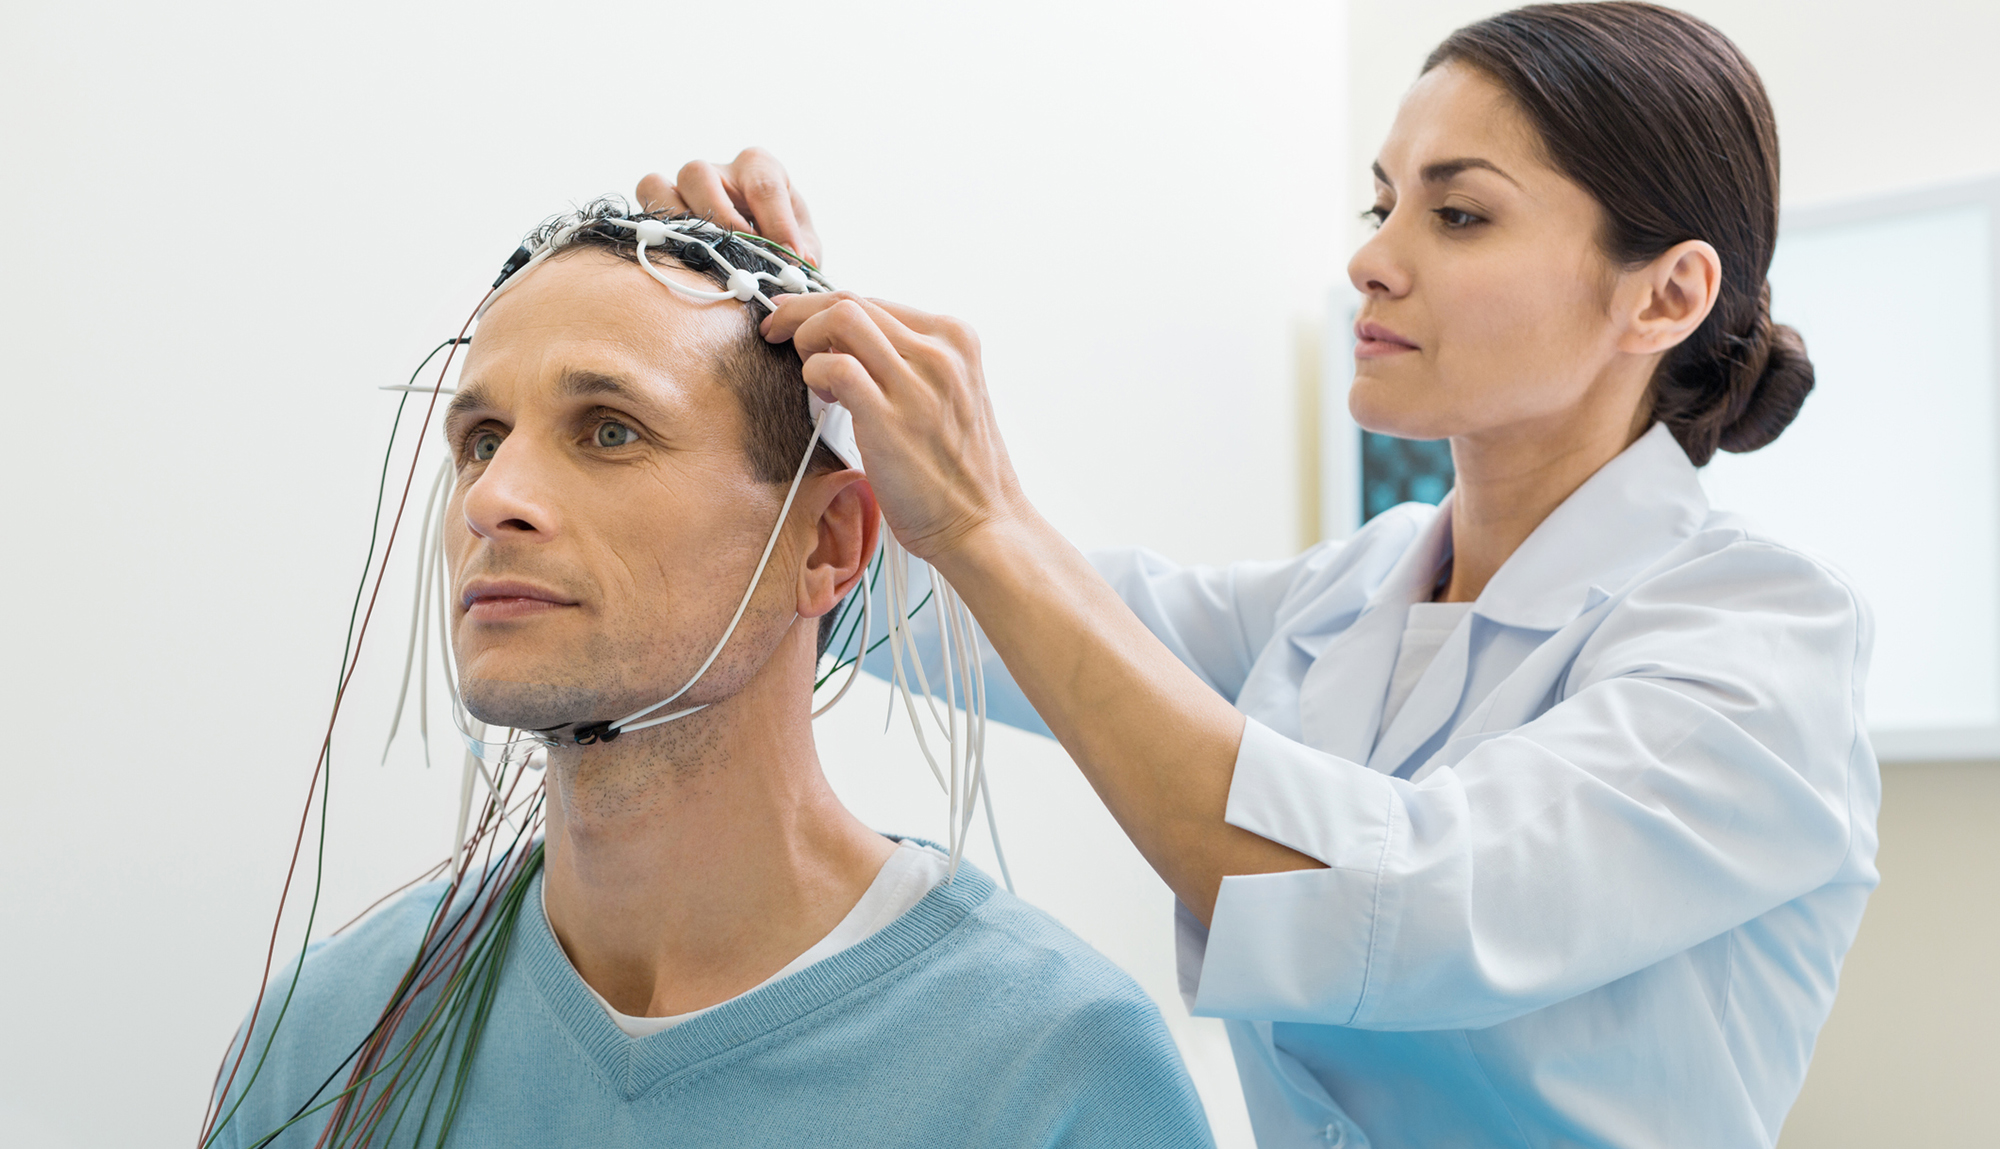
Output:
[872, 426, 1880, 1149]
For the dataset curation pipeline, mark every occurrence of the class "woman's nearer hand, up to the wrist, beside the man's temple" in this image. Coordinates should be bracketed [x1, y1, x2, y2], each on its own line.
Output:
[764, 292, 1034, 577]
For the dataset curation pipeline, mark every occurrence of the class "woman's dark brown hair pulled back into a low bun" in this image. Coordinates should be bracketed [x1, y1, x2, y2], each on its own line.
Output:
[1424, 0, 1812, 466]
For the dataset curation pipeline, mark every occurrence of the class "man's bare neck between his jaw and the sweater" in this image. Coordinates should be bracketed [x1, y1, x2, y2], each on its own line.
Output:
[544, 627, 894, 1017]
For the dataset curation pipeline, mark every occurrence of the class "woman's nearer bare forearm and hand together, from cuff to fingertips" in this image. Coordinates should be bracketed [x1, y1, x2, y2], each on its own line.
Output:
[764, 292, 1320, 921]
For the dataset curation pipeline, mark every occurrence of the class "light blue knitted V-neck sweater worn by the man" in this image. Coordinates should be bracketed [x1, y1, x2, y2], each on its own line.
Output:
[216, 852, 1212, 1149]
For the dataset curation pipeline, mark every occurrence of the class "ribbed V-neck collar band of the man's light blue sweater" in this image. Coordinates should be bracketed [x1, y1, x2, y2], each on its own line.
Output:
[514, 863, 994, 1101]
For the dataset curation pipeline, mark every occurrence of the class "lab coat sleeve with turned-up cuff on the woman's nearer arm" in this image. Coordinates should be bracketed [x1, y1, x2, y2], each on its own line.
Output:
[1196, 538, 1880, 1029]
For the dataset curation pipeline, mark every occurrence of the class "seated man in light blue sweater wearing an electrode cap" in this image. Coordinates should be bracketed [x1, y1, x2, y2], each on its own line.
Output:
[216, 206, 1210, 1147]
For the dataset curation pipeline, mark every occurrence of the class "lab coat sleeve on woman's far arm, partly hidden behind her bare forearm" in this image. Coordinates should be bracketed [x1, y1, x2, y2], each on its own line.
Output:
[862, 542, 1338, 737]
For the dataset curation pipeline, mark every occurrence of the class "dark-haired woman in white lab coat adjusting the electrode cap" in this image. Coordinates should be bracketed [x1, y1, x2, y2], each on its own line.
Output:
[642, 2, 1880, 1147]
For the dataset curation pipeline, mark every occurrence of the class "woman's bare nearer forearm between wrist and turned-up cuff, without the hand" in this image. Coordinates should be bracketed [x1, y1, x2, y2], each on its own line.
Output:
[936, 510, 1320, 923]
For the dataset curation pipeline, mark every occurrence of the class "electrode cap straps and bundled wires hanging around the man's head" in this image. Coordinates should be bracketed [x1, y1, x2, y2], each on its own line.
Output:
[200, 198, 1014, 1149]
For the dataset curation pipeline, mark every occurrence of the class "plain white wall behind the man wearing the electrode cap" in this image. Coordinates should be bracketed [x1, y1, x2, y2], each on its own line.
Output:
[0, 0, 1346, 1147]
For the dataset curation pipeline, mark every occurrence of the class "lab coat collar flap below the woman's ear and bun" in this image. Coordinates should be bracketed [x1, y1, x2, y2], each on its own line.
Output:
[1464, 422, 1708, 631]
